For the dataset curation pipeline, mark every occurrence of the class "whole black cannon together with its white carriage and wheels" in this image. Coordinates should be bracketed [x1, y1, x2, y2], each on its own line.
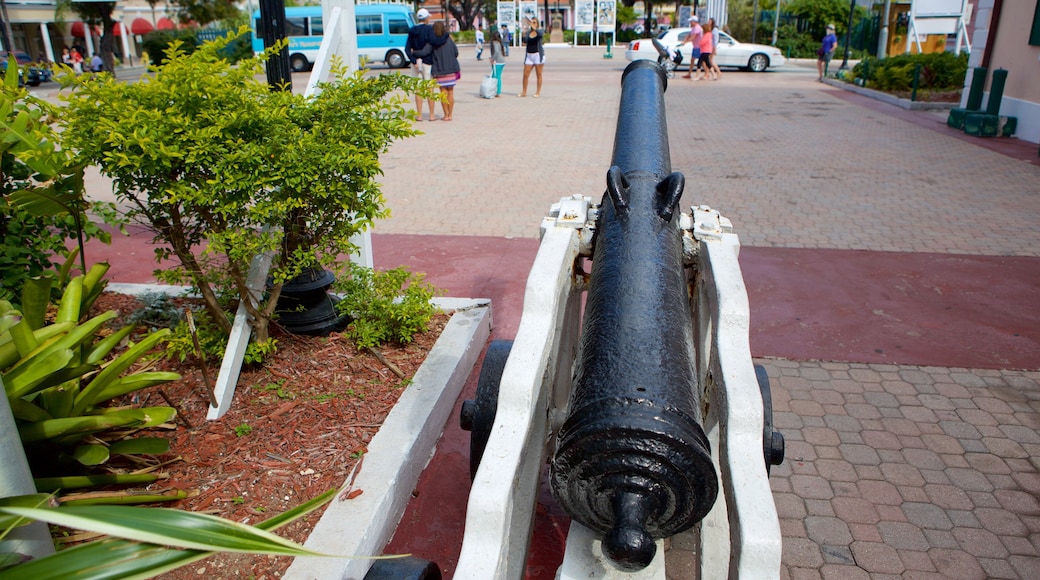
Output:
[456, 60, 783, 579]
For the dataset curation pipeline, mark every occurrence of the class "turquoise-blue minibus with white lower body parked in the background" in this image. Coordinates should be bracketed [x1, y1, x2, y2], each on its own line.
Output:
[253, 4, 415, 73]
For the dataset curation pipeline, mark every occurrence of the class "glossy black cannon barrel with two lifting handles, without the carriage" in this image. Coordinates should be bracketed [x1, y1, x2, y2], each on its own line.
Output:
[550, 60, 719, 571]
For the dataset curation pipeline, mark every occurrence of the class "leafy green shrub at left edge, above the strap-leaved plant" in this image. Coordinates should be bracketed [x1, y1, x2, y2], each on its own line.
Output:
[0, 61, 119, 309]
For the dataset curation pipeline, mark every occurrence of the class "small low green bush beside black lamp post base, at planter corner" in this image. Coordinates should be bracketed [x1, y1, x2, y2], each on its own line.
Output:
[334, 263, 437, 348]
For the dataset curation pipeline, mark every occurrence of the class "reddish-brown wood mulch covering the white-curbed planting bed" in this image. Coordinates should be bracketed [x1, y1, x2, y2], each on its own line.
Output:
[83, 293, 449, 580]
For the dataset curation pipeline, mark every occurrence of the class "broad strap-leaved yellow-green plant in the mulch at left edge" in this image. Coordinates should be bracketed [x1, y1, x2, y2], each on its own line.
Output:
[0, 272, 180, 486]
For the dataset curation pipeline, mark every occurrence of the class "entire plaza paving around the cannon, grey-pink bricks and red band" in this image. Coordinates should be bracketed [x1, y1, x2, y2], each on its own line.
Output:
[83, 47, 1040, 579]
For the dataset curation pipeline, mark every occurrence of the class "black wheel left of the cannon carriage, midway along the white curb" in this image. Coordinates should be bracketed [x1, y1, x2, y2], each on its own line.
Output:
[459, 340, 513, 479]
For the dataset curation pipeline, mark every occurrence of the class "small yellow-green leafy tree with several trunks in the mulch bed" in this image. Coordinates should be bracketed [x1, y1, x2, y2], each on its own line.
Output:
[61, 28, 432, 341]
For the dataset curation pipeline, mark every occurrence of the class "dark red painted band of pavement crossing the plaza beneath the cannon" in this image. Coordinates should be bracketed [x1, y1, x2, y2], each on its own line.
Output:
[87, 230, 1040, 579]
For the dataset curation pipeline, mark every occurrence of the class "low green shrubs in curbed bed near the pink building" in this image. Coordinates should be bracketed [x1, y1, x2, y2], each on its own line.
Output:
[846, 52, 968, 91]
